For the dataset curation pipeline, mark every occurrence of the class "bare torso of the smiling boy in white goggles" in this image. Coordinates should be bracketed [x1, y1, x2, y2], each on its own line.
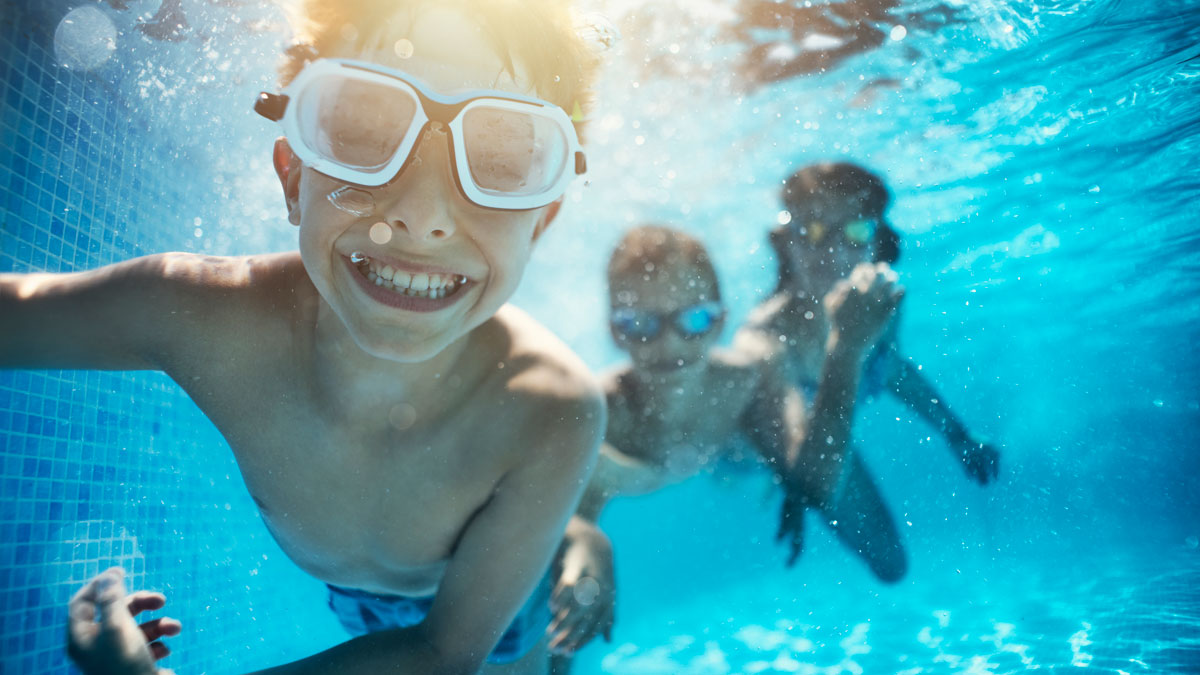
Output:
[168, 252, 580, 596]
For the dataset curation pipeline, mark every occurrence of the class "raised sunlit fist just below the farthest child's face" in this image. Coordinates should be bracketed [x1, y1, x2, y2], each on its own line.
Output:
[823, 263, 904, 351]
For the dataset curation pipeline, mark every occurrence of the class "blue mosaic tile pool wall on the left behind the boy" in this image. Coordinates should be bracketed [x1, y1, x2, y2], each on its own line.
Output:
[0, 1, 344, 674]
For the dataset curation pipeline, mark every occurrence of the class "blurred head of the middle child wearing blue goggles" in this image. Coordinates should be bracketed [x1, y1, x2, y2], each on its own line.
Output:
[608, 226, 725, 372]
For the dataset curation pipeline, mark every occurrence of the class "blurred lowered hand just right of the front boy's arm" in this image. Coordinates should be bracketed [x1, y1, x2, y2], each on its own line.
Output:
[546, 518, 617, 656]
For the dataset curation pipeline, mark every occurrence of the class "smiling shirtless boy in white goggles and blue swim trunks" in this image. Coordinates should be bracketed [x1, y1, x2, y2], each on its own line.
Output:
[7, 0, 606, 675]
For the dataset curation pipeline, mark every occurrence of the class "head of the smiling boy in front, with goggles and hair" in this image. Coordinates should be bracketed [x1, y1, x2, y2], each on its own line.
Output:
[264, 0, 592, 362]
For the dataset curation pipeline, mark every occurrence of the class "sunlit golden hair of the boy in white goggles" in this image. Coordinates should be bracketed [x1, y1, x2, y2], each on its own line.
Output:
[280, 0, 598, 130]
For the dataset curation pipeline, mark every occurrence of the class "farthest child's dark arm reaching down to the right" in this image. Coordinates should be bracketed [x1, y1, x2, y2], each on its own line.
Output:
[888, 351, 1000, 485]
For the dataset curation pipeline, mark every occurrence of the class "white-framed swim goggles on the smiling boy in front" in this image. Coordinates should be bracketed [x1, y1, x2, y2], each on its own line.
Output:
[254, 59, 587, 210]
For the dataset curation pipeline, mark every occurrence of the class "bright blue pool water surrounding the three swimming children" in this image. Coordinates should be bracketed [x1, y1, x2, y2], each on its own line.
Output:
[0, 0, 1200, 674]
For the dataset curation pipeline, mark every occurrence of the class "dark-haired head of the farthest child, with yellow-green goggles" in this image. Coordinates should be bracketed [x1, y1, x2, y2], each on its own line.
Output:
[770, 162, 900, 294]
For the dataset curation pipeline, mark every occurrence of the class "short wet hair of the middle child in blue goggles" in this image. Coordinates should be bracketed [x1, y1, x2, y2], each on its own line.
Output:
[608, 225, 721, 300]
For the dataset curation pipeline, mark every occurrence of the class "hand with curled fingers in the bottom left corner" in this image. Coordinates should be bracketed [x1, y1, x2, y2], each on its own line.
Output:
[67, 567, 180, 675]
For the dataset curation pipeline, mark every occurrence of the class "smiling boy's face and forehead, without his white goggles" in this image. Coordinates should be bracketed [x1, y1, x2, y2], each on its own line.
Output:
[276, 2, 558, 362]
